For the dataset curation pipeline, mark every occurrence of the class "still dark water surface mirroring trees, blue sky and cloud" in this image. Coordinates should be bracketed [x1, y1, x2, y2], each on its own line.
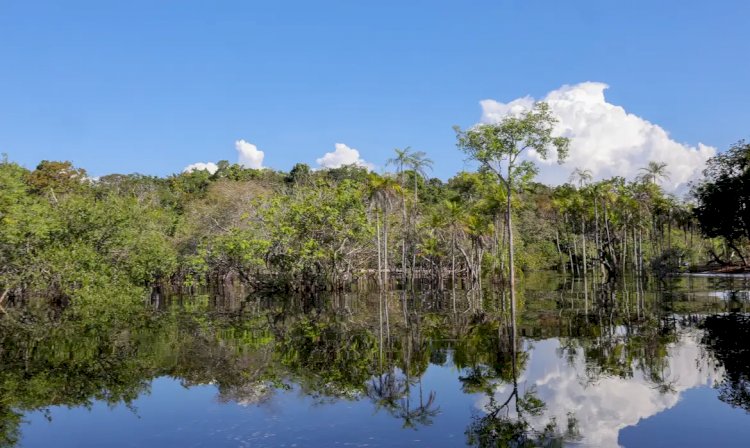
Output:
[0, 274, 750, 447]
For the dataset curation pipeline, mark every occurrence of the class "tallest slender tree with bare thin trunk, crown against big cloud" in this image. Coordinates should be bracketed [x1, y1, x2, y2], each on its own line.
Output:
[454, 102, 570, 340]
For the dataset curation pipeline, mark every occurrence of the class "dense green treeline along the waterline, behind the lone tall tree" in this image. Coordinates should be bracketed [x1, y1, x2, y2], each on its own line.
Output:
[0, 136, 750, 305]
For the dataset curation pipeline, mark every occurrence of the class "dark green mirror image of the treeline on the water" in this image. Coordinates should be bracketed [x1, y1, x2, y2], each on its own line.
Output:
[0, 274, 750, 446]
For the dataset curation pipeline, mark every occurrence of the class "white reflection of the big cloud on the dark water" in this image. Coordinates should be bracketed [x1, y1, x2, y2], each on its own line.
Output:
[477, 329, 723, 447]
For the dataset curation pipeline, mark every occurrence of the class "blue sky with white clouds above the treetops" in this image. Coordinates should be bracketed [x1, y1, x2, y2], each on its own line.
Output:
[0, 0, 750, 189]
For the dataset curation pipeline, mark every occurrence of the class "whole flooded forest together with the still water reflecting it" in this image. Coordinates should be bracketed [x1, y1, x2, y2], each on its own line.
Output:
[0, 114, 750, 447]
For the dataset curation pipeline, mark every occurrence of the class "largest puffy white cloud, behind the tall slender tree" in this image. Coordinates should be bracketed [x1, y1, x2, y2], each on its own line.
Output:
[480, 82, 716, 191]
